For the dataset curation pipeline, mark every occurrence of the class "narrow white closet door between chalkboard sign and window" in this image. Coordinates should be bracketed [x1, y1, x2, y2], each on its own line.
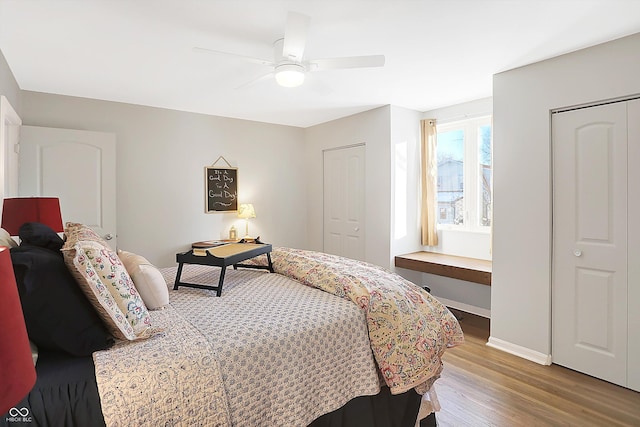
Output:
[323, 145, 365, 261]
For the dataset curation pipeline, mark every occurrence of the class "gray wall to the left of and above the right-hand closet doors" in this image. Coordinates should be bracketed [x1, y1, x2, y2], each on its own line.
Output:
[490, 34, 640, 359]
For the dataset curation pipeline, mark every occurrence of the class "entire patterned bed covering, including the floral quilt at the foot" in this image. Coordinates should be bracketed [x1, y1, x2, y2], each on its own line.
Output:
[94, 248, 463, 426]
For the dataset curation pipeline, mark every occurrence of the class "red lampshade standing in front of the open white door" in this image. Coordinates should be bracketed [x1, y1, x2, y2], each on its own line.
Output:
[2, 197, 64, 236]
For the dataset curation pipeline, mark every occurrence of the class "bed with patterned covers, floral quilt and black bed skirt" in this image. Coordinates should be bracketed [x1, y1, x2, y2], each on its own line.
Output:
[0, 225, 463, 427]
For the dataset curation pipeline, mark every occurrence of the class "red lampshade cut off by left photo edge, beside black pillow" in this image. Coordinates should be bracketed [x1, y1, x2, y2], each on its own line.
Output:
[0, 246, 36, 414]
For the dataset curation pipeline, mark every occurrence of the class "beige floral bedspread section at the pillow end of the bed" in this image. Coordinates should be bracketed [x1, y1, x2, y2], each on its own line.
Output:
[93, 307, 230, 427]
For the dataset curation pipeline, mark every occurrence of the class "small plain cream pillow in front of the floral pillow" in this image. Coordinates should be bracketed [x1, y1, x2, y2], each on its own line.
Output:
[118, 249, 169, 310]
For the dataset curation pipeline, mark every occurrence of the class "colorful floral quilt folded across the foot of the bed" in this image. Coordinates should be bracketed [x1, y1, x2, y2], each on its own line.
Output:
[271, 248, 464, 394]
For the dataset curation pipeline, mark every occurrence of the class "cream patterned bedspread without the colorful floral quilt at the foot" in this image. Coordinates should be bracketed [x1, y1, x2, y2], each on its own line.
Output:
[94, 265, 380, 426]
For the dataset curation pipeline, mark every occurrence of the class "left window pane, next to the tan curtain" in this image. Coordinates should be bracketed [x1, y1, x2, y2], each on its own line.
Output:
[437, 129, 464, 224]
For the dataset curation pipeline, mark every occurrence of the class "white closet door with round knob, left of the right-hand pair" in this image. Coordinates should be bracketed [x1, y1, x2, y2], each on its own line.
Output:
[552, 103, 638, 386]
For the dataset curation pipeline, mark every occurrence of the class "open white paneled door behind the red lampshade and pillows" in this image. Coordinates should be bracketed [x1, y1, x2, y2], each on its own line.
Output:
[19, 126, 117, 249]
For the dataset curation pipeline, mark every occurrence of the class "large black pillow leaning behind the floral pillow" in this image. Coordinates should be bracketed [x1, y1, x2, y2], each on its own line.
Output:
[11, 246, 113, 356]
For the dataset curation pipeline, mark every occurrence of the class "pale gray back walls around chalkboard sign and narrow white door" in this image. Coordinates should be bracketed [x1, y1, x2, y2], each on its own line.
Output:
[22, 91, 410, 268]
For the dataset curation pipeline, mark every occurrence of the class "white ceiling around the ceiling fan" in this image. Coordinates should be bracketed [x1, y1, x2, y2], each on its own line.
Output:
[0, 0, 640, 127]
